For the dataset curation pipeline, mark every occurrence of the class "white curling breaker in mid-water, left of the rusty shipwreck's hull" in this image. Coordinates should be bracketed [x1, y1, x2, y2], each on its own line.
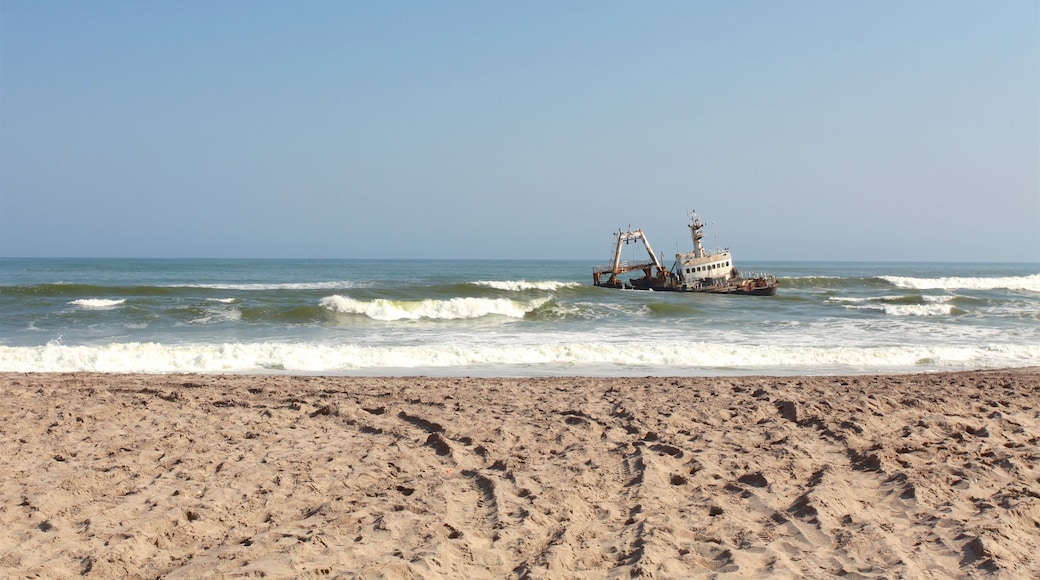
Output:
[318, 295, 549, 320]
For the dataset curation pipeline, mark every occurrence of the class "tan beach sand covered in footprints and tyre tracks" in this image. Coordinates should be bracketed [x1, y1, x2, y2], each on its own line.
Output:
[0, 369, 1040, 578]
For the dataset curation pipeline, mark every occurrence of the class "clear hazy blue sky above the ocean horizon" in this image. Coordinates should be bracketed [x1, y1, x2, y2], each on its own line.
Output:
[0, 0, 1040, 262]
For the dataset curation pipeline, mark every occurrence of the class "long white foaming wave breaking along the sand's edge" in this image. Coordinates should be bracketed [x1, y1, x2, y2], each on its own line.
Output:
[0, 341, 1040, 376]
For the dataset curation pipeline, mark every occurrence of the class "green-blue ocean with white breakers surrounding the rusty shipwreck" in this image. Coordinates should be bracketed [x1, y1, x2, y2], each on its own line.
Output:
[0, 258, 1040, 376]
